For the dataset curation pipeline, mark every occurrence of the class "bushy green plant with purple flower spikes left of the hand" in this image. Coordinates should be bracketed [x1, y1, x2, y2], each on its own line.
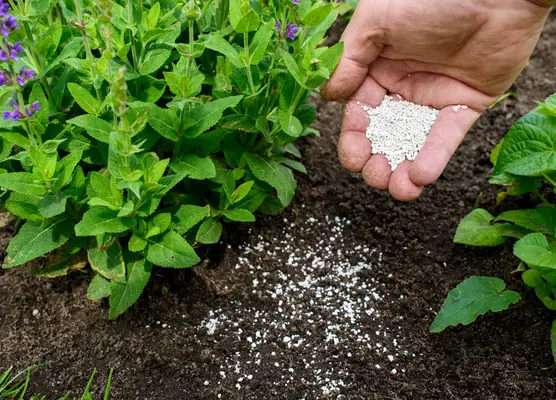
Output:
[0, 0, 343, 318]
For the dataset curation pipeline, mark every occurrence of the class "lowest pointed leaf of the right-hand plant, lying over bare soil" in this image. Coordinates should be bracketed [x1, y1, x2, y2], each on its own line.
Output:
[429, 276, 521, 333]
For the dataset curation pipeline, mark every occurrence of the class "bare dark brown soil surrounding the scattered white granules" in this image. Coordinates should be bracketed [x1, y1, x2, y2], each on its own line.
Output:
[0, 15, 556, 400]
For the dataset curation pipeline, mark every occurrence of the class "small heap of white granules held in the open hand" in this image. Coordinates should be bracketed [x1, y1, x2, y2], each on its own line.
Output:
[362, 96, 440, 171]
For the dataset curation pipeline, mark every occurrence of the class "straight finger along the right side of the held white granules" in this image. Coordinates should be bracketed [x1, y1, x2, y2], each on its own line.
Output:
[409, 106, 481, 186]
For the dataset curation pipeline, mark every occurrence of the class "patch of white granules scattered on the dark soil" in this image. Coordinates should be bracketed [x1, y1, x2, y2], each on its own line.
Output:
[191, 212, 415, 398]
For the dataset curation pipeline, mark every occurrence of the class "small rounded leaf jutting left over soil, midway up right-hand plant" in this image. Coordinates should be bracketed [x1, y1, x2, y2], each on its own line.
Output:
[454, 208, 513, 247]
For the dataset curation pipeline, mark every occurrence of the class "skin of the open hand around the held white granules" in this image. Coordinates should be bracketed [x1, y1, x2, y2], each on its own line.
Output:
[321, 0, 556, 201]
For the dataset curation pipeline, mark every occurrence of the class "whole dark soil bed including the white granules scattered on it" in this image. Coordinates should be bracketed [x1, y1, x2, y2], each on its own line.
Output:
[0, 16, 556, 399]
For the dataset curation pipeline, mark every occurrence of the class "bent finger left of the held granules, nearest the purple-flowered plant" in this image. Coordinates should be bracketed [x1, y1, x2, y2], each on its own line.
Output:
[338, 77, 386, 173]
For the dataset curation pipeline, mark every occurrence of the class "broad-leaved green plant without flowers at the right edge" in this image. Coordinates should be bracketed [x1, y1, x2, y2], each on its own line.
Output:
[430, 94, 556, 360]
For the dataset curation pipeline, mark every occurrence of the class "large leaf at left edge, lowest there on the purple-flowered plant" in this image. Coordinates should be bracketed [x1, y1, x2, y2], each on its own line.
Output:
[3, 220, 74, 268]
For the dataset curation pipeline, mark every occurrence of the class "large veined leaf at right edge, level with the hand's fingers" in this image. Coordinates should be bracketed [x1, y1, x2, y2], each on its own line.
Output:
[493, 95, 556, 177]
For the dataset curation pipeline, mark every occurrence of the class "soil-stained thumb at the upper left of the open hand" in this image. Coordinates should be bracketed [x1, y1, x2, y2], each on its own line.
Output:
[321, 1, 386, 100]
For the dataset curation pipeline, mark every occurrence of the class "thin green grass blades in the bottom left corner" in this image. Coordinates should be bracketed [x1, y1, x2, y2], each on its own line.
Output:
[0, 365, 113, 400]
